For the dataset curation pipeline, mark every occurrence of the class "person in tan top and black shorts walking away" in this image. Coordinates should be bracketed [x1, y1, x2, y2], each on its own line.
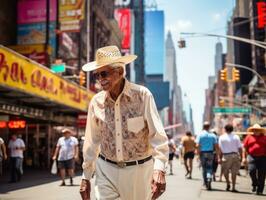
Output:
[181, 131, 196, 179]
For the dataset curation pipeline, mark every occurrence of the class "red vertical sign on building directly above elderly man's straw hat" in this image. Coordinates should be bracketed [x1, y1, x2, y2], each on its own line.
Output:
[115, 8, 131, 49]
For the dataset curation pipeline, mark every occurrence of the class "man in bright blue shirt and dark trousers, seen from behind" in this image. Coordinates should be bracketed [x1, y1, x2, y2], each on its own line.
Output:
[196, 121, 218, 190]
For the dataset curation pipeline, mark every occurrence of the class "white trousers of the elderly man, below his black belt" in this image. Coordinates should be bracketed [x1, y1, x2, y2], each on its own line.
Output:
[95, 158, 153, 200]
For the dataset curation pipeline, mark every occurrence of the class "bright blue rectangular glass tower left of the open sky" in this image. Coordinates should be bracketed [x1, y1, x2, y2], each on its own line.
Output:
[145, 10, 165, 75]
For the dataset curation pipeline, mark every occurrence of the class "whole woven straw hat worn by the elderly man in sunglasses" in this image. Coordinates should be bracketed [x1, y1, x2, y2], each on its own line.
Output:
[82, 46, 137, 72]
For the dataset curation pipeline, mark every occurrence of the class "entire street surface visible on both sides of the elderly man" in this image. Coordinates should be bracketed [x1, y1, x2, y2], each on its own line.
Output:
[0, 160, 265, 200]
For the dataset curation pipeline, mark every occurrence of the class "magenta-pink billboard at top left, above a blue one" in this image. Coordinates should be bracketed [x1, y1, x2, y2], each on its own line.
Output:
[17, 0, 57, 24]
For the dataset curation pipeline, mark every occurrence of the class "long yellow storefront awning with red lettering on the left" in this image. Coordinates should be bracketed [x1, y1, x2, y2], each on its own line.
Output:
[0, 45, 93, 122]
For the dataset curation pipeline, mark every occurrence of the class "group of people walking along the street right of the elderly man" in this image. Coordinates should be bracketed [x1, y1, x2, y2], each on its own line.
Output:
[169, 122, 266, 195]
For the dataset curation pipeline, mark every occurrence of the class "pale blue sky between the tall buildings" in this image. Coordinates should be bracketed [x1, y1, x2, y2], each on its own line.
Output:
[156, 0, 235, 134]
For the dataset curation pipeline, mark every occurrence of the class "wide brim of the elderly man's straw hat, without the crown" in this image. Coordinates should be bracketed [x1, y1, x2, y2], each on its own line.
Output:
[82, 55, 137, 72]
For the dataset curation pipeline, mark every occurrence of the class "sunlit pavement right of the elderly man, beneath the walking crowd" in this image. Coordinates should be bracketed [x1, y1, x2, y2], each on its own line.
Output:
[160, 160, 266, 200]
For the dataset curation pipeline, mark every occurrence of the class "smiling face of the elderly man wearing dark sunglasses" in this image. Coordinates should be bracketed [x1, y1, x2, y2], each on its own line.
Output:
[93, 65, 123, 91]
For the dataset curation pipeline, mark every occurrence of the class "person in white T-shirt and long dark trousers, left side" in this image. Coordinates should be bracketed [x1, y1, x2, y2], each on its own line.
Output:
[8, 133, 25, 183]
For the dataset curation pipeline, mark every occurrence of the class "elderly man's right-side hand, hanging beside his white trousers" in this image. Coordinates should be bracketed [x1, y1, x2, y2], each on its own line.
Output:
[151, 170, 166, 200]
